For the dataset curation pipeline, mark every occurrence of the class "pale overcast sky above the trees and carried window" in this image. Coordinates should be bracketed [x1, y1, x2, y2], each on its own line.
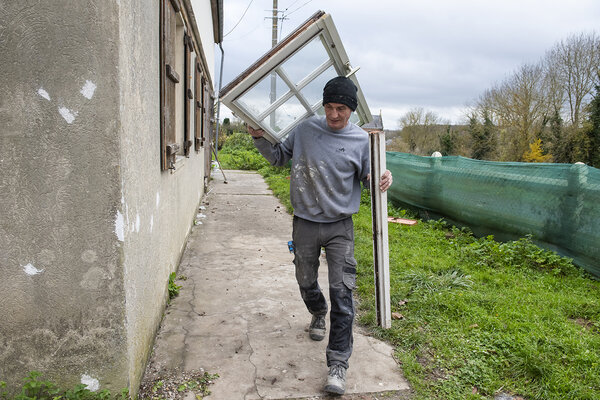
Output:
[215, 0, 600, 129]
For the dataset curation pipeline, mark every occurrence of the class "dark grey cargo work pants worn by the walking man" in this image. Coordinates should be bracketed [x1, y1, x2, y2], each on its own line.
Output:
[292, 216, 356, 368]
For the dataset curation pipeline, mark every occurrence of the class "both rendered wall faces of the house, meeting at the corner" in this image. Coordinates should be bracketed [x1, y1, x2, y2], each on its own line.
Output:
[0, 0, 213, 392]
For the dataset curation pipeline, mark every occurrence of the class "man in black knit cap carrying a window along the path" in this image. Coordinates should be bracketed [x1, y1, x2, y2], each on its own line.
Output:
[248, 76, 392, 394]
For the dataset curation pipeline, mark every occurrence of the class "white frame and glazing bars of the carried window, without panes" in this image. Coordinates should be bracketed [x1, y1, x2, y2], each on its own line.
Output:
[220, 11, 373, 143]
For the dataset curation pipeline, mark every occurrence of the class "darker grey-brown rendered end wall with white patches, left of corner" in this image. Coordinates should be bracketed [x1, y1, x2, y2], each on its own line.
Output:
[0, 0, 127, 387]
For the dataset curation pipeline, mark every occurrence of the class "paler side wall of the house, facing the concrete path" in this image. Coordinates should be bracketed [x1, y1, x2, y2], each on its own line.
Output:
[119, 0, 212, 390]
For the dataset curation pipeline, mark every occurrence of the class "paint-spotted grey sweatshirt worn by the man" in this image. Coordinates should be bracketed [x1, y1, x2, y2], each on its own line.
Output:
[254, 116, 370, 222]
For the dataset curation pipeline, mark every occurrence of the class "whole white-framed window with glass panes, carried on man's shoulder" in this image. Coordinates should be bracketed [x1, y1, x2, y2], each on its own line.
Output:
[221, 11, 372, 143]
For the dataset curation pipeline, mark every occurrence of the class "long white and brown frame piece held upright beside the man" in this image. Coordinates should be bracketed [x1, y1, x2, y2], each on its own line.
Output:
[369, 131, 392, 329]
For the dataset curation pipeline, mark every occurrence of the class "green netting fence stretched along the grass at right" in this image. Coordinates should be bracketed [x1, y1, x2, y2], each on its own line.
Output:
[386, 152, 600, 276]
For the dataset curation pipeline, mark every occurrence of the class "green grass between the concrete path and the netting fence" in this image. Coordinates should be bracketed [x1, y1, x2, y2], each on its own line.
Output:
[219, 136, 600, 400]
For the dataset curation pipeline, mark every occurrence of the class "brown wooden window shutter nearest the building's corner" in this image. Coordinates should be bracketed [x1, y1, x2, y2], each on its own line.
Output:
[160, 0, 180, 170]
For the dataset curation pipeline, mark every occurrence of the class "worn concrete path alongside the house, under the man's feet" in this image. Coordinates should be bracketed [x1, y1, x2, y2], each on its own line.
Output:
[146, 171, 409, 400]
